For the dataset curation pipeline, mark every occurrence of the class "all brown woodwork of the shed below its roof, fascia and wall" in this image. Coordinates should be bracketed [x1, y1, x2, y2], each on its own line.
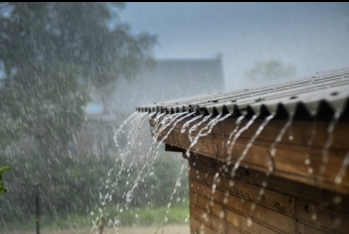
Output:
[150, 114, 349, 234]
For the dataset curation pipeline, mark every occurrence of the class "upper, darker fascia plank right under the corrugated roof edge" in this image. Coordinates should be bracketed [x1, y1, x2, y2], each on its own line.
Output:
[159, 118, 349, 150]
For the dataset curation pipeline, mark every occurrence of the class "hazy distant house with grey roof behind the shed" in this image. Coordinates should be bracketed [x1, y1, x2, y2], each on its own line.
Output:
[75, 55, 224, 154]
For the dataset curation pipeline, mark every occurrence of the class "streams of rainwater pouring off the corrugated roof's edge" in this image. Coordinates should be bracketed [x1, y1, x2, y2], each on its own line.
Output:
[93, 108, 349, 234]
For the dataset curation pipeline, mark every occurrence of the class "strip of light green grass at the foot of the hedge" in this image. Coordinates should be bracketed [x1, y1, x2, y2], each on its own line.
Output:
[0, 201, 189, 231]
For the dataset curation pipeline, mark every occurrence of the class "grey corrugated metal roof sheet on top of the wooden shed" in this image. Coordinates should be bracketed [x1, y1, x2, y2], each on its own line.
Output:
[136, 69, 349, 118]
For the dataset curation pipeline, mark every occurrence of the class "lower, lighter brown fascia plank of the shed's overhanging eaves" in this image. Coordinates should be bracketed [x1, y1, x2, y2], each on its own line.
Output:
[167, 128, 349, 194]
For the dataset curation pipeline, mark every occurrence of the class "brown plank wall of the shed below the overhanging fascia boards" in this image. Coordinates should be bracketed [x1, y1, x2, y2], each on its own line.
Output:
[188, 153, 349, 234]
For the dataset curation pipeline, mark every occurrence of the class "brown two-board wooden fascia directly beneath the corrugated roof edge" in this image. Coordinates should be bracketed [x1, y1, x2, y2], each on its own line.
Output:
[151, 118, 349, 195]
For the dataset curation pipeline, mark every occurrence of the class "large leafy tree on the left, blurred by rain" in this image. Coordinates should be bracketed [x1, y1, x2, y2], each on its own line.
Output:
[0, 2, 156, 221]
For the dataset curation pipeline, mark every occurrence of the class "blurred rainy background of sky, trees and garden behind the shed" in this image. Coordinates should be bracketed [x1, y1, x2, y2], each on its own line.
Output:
[0, 2, 349, 233]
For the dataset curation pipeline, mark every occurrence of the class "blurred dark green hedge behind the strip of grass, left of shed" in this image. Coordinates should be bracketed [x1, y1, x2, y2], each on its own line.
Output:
[0, 154, 188, 225]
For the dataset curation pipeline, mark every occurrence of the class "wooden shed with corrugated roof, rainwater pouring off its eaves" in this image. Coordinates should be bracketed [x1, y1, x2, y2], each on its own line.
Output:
[137, 70, 349, 234]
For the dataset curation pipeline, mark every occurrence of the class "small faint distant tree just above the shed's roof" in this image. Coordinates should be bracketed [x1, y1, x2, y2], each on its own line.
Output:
[245, 59, 296, 82]
